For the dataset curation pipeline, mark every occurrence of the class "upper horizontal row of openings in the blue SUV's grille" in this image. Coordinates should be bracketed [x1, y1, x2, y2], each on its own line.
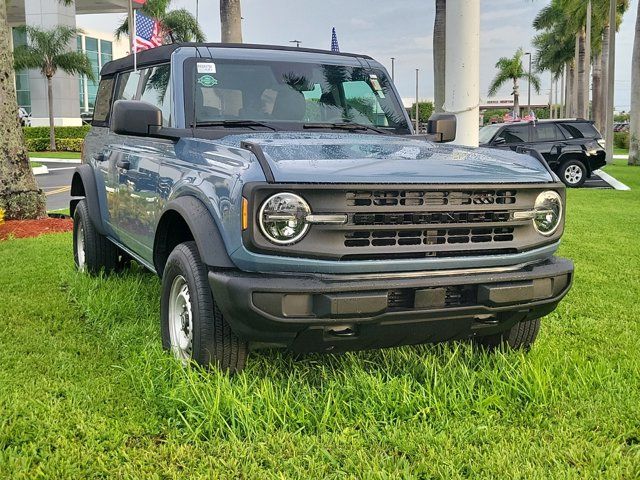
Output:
[346, 190, 516, 207]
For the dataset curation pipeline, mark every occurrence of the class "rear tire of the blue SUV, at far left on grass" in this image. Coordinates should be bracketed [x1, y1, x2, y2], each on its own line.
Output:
[73, 200, 119, 275]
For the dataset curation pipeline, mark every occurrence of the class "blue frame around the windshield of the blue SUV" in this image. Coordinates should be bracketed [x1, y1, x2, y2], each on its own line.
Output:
[182, 56, 413, 135]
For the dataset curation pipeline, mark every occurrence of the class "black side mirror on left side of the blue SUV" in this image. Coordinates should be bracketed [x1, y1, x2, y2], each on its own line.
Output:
[111, 100, 162, 137]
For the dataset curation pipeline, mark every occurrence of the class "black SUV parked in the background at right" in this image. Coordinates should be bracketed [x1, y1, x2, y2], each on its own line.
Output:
[480, 120, 607, 187]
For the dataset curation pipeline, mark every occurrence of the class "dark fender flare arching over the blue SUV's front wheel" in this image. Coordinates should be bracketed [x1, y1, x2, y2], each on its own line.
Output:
[153, 196, 236, 271]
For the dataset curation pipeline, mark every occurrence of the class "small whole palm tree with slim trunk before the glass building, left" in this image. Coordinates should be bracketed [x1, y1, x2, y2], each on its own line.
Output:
[13, 25, 95, 151]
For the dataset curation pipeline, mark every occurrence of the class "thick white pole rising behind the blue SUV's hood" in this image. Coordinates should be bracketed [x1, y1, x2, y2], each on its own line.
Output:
[444, 0, 480, 147]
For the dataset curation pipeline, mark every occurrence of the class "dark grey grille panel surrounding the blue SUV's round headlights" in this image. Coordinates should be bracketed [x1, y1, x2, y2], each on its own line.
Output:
[244, 184, 562, 261]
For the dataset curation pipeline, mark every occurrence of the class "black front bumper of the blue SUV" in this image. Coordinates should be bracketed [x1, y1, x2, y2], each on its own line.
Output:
[209, 257, 573, 352]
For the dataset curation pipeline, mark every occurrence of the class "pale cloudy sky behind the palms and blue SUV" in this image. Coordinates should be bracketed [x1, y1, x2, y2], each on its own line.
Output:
[78, 0, 638, 110]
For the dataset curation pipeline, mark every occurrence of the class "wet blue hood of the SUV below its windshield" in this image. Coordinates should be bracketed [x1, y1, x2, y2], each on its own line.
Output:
[214, 133, 553, 184]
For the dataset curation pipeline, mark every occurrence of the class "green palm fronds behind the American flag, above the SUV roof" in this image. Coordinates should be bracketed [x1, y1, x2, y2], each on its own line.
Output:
[115, 0, 205, 44]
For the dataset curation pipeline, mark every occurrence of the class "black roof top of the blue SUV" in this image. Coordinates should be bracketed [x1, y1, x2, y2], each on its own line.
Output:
[100, 42, 373, 76]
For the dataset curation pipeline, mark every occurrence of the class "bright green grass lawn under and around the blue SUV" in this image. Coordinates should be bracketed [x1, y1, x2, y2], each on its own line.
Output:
[0, 161, 640, 479]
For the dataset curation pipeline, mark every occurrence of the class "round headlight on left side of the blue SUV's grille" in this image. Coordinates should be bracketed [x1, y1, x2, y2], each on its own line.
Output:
[258, 193, 311, 245]
